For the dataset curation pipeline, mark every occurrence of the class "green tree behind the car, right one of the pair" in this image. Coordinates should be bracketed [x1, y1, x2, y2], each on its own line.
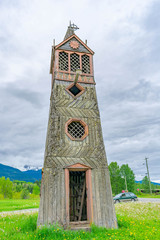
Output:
[120, 164, 136, 192]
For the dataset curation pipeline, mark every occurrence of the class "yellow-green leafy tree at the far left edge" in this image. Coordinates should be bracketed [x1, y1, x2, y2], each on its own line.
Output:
[0, 177, 13, 198]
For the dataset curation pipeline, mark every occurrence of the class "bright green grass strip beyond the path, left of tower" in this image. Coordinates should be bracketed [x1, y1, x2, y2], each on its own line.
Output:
[0, 199, 39, 212]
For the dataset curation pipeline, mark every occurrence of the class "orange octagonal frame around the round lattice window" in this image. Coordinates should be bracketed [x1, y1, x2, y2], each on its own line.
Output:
[65, 118, 88, 141]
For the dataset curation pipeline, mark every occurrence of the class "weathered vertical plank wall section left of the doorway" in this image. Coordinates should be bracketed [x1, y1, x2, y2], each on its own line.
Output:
[37, 169, 66, 226]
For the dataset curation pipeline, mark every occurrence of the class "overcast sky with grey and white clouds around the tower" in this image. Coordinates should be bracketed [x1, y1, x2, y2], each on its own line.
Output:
[0, 0, 160, 182]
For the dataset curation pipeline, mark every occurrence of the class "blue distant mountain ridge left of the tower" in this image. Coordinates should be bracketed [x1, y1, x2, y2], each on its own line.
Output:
[0, 164, 42, 182]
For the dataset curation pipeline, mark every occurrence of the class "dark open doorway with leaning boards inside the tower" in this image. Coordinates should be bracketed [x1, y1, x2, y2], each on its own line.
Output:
[69, 171, 87, 222]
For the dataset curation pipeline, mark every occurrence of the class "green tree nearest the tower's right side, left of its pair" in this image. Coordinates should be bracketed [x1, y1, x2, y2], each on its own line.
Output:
[109, 162, 124, 194]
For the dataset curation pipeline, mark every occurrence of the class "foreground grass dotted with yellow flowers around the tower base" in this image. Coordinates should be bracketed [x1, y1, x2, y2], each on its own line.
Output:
[0, 202, 160, 240]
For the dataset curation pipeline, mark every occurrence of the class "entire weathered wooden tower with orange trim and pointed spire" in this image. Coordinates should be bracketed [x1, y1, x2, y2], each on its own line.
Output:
[37, 23, 117, 229]
